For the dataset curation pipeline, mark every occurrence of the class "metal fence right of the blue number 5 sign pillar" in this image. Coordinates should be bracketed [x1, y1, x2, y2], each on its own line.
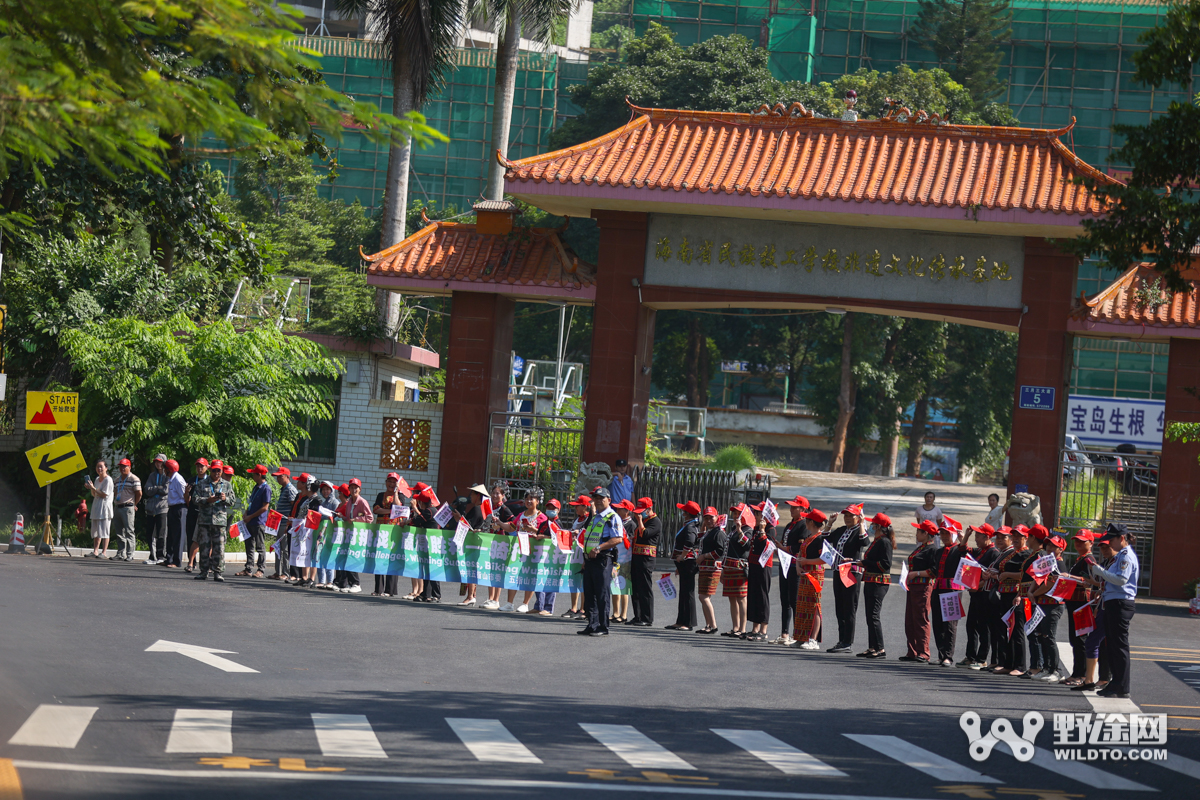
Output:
[1057, 447, 1159, 590]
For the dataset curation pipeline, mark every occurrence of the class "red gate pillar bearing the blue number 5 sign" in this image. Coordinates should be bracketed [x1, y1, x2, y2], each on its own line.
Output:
[1008, 237, 1076, 525]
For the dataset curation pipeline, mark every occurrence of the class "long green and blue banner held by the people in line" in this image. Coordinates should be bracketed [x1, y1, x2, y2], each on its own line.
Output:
[317, 519, 583, 591]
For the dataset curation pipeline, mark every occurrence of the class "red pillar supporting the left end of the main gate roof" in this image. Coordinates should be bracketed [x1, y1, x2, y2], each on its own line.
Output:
[583, 211, 654, 464]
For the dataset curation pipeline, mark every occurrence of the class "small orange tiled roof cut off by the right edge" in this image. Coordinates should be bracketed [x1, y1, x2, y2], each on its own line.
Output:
[1073, 264, 1200, 331]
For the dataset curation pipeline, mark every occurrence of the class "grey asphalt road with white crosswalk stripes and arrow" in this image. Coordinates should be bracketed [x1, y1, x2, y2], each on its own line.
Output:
[0, 555, 1200, 800]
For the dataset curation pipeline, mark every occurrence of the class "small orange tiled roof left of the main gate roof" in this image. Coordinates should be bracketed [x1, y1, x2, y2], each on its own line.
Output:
[362, 222, 595, 290]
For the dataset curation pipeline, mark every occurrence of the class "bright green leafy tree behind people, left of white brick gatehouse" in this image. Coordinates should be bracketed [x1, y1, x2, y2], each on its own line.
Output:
[61, 314, 340, 467]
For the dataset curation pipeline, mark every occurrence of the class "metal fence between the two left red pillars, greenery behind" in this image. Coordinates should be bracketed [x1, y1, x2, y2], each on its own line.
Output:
[487, 411, 583, 504]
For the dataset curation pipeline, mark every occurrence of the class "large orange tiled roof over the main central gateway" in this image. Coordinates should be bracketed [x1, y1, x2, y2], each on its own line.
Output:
[504, 107, 1118, 215]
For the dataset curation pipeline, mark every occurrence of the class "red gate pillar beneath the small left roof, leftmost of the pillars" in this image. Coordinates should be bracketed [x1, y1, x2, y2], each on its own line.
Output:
[438, 291, 516, 500]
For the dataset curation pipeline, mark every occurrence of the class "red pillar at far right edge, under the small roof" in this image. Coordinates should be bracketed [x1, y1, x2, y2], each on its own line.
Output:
[1150, 338, 1200, 599]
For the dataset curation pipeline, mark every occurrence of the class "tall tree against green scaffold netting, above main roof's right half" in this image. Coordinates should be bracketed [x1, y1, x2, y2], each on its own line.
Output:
[912, 0, 1013, 103]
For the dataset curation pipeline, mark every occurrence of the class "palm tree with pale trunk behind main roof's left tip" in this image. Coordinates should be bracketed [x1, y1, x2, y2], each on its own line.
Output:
[469, 0, 578, 200]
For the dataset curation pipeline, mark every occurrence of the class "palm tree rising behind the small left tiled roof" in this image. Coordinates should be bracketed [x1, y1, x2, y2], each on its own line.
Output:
[337, 0, 463, 247]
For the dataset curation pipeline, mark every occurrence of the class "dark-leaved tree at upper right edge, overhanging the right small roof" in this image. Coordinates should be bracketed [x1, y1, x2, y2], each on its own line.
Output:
[1063, 0, 1200, 291]
